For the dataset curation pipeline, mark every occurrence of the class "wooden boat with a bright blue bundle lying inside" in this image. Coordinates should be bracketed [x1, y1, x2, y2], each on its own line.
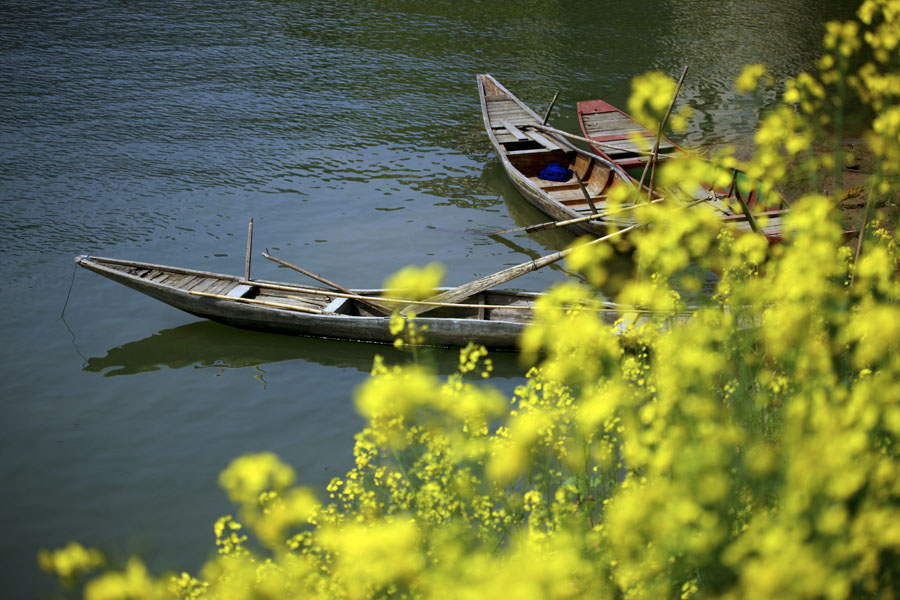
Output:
[477, 74, 634, 235]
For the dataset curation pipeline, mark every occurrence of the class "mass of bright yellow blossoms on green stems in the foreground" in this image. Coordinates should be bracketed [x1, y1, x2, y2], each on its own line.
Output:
[38, 0, 900, 600]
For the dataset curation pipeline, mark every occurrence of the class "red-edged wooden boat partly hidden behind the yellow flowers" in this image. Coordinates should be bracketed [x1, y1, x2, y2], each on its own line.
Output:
[577, 100, 787, 241]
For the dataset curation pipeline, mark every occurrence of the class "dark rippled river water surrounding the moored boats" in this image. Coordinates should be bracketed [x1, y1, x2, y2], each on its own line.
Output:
[0, 0, 855, 597]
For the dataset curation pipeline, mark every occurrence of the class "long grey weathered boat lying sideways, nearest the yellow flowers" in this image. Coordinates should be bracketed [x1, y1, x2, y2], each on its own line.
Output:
[75, 256, 636, 349]
